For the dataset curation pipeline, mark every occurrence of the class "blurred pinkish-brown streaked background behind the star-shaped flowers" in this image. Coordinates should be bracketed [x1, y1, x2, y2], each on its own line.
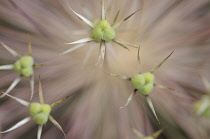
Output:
[0, 0, 210, 139]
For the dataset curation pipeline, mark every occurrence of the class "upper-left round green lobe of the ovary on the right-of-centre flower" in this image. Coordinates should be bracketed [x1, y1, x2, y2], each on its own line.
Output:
[131, 74, 145, 89]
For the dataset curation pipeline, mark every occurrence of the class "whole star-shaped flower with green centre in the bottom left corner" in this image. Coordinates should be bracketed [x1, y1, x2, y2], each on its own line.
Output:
[0, 78, 69, 139]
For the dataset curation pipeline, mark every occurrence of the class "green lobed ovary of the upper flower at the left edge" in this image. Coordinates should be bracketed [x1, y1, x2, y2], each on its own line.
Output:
[14, 56, 34, 77]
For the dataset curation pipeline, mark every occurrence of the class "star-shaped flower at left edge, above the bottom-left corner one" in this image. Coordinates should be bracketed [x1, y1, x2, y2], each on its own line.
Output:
[0, 37, 41, 99]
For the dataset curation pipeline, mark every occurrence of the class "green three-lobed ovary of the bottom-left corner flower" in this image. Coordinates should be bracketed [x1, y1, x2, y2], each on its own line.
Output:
[29, 103, 51, 125]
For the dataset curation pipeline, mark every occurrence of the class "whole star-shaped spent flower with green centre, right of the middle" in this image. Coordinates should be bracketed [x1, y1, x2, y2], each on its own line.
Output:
[109, 47, 178, 123]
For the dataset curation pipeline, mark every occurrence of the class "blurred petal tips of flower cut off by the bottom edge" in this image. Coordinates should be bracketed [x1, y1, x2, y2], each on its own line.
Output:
[133, 129, 164, 139]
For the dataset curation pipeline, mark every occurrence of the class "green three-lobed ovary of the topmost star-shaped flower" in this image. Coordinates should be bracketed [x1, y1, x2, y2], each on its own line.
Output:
[91, 20, 115, 42]
